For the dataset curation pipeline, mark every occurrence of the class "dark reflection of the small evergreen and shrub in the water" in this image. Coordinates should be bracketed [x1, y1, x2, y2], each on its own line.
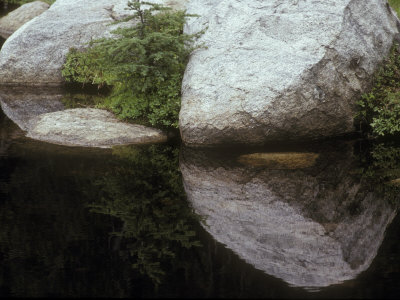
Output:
[90, 145, 199, 284]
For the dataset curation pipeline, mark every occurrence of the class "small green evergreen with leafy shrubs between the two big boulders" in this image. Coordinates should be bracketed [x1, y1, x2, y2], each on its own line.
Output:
[62, 0, 202, 128]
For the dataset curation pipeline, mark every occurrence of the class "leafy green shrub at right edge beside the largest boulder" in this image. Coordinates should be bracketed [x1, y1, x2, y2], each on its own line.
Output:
[356, 45, 400, 136]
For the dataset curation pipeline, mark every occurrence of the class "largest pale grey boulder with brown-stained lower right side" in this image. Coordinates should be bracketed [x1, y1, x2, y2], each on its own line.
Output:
[180, 0, 399, 145]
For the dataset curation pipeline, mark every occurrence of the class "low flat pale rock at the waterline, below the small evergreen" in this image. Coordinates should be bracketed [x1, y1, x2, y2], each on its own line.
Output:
[28, 108, 167, 148]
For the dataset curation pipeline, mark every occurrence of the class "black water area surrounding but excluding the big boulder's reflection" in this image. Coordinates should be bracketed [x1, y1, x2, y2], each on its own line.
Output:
[0, 107, 400, 298]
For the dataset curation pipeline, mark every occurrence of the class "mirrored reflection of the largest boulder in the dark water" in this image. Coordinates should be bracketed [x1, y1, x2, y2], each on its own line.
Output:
[180, 145, 396, 287]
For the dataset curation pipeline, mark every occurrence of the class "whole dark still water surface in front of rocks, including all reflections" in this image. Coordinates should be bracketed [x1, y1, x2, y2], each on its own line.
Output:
[0, 105, 400, 298]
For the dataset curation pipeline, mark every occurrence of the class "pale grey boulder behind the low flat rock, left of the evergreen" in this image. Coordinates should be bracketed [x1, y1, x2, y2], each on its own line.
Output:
[0, 0, 127, 85]
